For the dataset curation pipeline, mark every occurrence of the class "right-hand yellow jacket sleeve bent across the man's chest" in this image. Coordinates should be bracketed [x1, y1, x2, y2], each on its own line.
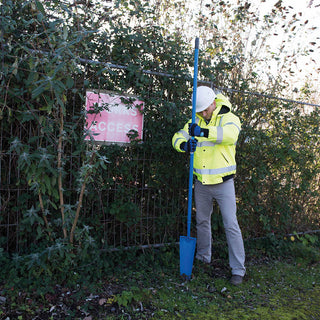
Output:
[208, 114, 241, 145]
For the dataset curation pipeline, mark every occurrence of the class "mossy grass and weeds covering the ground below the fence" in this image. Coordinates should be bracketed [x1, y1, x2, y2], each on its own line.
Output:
[0, 238, 320, 320]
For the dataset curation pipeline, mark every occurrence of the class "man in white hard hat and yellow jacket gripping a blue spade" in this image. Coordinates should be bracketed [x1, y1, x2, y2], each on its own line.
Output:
[172, 86, 246, 285]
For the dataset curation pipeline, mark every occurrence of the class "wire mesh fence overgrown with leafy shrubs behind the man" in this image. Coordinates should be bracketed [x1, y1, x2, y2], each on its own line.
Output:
[0, 2, 320, 252]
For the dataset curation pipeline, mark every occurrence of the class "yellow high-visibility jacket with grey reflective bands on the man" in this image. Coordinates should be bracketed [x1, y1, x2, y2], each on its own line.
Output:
[172, 94, 241, 184]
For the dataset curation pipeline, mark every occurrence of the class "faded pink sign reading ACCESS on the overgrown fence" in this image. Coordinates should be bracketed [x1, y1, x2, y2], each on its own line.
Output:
[85, 91, 144, 143]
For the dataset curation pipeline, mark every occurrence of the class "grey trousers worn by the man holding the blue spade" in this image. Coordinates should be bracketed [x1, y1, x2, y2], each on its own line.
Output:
[194, 179, 246, 276]
